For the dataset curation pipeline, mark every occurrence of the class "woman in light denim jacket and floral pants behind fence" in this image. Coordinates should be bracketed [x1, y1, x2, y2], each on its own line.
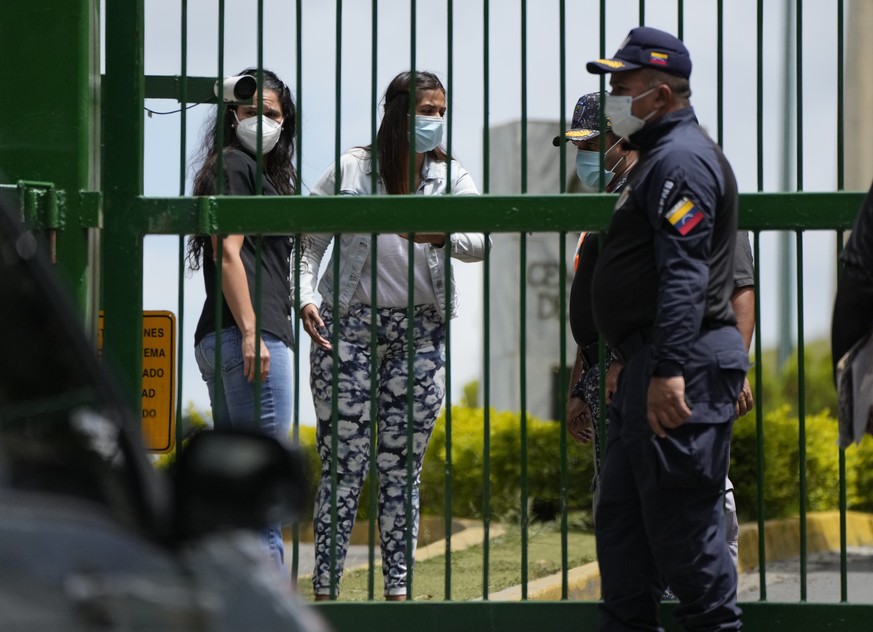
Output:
[300, 72, 486, 601]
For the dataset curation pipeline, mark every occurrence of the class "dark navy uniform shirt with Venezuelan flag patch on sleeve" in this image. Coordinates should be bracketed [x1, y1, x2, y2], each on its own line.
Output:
[592, 107, 737, 376]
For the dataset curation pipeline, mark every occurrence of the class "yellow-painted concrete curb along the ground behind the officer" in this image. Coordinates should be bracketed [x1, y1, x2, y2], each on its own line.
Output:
[489, 511, 873, 601]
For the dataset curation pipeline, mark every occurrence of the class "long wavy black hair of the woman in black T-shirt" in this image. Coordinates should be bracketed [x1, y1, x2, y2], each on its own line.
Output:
[187, 68, 298, 270]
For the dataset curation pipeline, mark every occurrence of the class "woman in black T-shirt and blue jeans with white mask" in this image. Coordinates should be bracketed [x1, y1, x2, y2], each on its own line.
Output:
[188, 68, 297, 574]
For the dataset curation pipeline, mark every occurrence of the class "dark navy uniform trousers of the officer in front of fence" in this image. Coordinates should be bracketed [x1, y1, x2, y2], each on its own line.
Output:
[596, 327, 748, 631]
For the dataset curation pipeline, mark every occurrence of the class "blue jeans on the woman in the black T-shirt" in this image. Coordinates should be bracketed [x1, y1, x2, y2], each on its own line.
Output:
[194, 327, 291, 572]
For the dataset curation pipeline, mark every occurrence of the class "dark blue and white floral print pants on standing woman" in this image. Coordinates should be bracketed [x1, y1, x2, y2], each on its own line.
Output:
[310, 305, 445, 596]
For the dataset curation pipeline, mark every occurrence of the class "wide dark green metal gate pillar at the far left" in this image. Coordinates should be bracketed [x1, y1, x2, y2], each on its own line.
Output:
[0, 0, 100, 334]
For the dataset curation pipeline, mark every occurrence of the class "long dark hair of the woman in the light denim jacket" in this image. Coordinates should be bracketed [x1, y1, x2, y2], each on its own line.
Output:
[376, 71, 448, 194]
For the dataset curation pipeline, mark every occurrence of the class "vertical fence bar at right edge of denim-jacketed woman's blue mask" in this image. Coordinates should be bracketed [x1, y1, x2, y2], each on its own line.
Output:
[443, 0, 456, 601]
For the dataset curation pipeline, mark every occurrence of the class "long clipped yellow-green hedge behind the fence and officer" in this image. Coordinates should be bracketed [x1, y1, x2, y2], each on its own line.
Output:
[300, 405, 873, 521]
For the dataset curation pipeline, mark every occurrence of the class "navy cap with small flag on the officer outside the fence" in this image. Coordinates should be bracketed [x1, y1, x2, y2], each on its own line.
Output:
[586, 26, 691, 79]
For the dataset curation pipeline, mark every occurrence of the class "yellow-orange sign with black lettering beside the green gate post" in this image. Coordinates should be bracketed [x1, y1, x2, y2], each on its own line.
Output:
[97, 310, 176, 454]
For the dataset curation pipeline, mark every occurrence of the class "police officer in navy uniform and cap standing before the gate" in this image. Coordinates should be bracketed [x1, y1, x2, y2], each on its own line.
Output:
[587, 27, 748, 631]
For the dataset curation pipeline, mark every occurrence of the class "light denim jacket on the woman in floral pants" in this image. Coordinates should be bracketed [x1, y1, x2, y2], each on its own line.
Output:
[291, 148, 490, 320]
